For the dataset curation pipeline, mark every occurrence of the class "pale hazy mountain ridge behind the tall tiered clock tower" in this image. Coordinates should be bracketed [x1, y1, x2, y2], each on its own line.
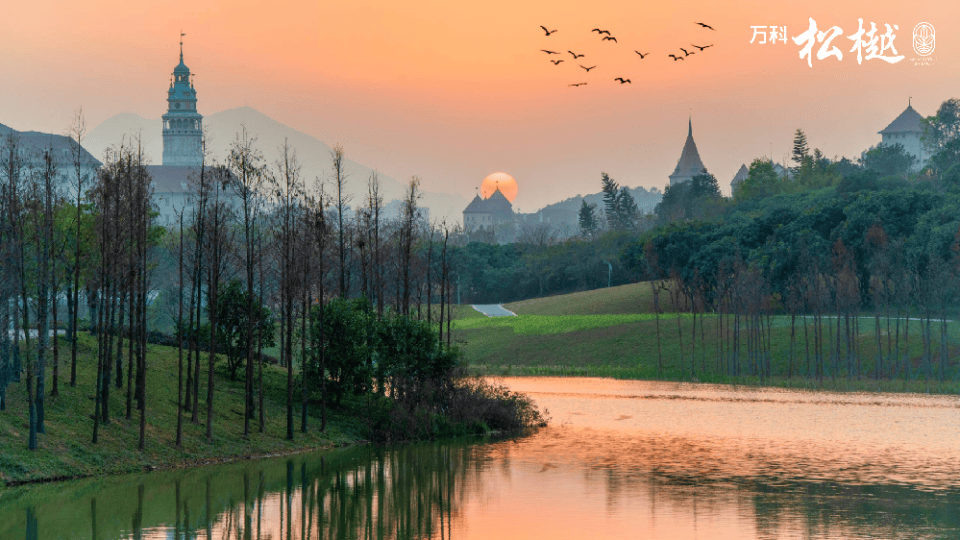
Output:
[83, 107, 467, 222]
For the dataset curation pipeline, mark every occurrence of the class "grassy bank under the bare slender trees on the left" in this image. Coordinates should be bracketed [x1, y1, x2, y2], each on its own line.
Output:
[0, 335, 359, 482]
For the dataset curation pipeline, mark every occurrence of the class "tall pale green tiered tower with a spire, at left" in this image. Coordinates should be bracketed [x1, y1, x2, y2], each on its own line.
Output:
[162, 33, 203, 167]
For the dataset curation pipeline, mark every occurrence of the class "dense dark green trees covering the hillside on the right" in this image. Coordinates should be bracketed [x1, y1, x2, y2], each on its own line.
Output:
[621, 100, 960, 381]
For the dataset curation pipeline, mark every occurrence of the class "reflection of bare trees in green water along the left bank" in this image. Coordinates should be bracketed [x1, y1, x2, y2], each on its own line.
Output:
[0, 443, 479, 540]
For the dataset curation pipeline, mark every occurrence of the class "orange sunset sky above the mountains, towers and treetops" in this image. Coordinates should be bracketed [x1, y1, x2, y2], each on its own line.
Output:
[0, 0, 960, 212]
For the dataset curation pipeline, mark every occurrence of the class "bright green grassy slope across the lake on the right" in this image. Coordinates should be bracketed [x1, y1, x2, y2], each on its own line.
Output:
[454, 284, 960, 392]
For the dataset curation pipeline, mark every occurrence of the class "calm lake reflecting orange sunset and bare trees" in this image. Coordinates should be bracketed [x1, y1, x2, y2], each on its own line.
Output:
[0, 378, 960, 540]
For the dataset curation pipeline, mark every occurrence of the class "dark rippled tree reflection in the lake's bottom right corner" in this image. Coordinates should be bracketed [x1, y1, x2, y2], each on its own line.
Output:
[582, 465, 960, 540]
